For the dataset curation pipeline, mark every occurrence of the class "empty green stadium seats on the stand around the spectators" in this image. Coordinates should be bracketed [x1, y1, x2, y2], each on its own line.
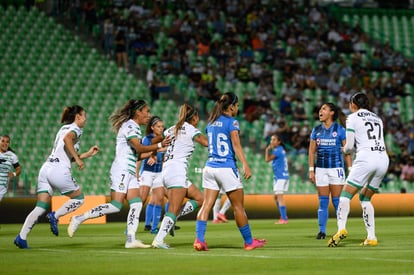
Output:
[0, 2, 414, 195]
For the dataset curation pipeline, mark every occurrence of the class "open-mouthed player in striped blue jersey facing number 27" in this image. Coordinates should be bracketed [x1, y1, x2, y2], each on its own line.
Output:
[308, 103, 351, 240]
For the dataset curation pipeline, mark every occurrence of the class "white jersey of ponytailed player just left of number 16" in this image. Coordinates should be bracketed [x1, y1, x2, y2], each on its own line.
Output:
[163, 122, 201, 169]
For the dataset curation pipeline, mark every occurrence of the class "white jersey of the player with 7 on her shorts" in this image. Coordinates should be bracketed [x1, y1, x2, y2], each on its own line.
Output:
[111, 119, 142, 175]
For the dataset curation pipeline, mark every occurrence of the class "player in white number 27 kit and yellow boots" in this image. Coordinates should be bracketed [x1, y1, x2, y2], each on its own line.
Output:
[328, 92, 389, 247]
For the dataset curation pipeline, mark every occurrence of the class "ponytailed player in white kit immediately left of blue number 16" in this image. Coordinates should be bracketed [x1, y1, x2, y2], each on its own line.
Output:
[152, 104, 208, 249]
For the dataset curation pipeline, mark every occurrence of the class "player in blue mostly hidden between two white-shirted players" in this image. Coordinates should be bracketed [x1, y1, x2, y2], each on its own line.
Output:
[138, 116, 165, 234]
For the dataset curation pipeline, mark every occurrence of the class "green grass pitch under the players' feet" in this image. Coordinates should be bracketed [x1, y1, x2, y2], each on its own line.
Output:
[0, 217, 414, 275]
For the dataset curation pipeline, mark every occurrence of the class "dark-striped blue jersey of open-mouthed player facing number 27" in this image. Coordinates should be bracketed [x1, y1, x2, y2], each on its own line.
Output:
[311, 122, 346, 168]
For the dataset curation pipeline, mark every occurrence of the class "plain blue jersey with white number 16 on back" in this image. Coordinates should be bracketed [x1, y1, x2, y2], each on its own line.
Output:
[206, 115, 240, 169]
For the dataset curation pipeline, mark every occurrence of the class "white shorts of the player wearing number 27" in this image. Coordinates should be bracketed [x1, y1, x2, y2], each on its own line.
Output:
[347, 154, 389, 190]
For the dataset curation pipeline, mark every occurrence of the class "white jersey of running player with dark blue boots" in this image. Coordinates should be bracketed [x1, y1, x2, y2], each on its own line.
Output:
[48, 122, 82, 168]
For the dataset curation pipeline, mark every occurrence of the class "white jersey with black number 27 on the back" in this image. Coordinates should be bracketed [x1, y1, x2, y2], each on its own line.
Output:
[346, 109, 387, 156]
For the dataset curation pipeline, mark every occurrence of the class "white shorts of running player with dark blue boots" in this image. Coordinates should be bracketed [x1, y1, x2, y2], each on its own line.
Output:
[37, 162, 80, 196]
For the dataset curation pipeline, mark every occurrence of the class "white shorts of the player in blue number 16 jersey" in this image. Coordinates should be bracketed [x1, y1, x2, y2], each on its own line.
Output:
[203, 167, 243, 193]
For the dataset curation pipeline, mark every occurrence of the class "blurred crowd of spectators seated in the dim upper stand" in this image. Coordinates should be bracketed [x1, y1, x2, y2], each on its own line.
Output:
[29, 0, 414, 185]
